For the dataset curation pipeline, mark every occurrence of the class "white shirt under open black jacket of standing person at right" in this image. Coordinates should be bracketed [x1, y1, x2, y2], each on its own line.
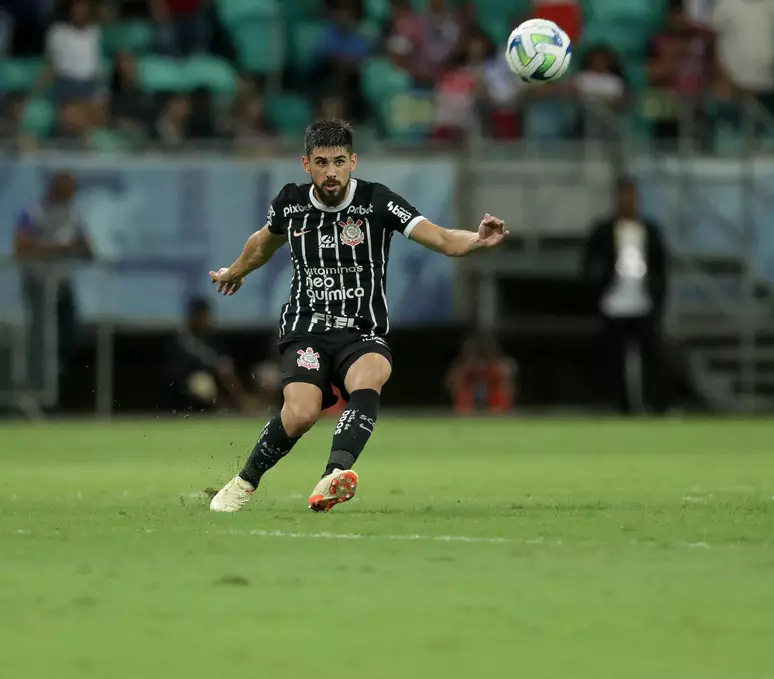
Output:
[601, 220, 653, 318]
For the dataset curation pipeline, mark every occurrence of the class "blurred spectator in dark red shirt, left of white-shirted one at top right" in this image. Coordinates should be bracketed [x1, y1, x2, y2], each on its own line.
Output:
[646, 0, 712, 139]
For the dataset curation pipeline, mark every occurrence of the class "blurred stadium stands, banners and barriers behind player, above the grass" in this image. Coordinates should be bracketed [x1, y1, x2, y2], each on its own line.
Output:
[0, 0, 774, 416]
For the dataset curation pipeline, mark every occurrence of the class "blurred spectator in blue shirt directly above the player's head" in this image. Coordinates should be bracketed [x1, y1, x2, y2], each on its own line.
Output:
[313, 0, 373, 121]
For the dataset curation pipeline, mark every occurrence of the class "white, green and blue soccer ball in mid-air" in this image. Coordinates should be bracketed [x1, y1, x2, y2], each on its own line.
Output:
[505, 19, 572, 83]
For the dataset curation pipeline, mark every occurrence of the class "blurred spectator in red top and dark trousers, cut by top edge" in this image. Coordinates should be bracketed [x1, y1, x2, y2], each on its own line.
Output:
[150, 0, 212, 57]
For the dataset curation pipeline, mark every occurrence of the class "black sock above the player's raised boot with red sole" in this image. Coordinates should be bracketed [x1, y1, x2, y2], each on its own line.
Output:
[324, 389, 380, 476]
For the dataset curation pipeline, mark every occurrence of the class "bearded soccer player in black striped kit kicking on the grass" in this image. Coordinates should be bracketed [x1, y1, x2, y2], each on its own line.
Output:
[210, 120, 508, 512]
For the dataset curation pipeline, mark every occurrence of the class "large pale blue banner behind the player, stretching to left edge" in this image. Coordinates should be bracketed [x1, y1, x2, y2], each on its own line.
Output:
[0, 154, 455, 327]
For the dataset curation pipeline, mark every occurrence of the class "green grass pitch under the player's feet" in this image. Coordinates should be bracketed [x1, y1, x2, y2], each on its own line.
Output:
[0, 416, 774, 679]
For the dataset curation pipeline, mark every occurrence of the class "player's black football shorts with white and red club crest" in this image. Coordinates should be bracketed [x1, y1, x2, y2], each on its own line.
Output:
[279, 328, 392, 410]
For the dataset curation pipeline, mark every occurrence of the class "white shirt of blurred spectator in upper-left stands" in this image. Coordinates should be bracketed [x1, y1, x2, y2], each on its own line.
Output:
[46, 24, 102, 82]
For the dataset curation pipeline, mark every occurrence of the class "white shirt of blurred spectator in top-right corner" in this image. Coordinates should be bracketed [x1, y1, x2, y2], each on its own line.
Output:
[712, 0, 774, 92]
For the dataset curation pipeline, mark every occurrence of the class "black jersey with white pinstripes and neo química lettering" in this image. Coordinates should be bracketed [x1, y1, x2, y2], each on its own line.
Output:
[266, 178, 424, 337]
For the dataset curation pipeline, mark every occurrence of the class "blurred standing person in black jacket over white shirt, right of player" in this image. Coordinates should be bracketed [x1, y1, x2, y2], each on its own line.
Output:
[583, 178, 669, 413]
